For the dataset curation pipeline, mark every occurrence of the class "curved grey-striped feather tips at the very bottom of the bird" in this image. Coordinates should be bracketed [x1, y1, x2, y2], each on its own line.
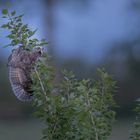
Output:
[12, 84, 34, 102]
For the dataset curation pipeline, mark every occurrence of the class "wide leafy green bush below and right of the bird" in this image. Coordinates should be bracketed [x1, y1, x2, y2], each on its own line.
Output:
[33, 63, 115, 140]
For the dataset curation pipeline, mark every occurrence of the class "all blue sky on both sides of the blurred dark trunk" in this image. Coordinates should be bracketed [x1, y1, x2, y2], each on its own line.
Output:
[0, 0, 139, 63]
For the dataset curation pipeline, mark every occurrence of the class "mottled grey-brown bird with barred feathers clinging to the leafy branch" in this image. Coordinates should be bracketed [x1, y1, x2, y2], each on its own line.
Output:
[8, 47, 43, 101]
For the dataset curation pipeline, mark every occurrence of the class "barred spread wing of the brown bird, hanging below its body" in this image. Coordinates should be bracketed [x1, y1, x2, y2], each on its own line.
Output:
[9, 67, 33, 101]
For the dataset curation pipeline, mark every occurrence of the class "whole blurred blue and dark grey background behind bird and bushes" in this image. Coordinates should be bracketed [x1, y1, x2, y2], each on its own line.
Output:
[0, 0, 140, 140]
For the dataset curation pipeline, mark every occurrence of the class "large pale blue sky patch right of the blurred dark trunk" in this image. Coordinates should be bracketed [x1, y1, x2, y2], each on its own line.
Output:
[54, 0, 139, 63]
